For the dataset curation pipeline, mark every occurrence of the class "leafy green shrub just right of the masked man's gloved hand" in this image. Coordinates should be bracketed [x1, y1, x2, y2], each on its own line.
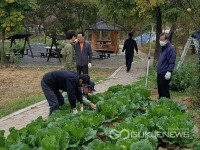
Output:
[170, 63, 198, 91]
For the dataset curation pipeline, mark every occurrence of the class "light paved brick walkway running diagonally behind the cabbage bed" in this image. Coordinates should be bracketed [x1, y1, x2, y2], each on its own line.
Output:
[0, 52, 152, 136]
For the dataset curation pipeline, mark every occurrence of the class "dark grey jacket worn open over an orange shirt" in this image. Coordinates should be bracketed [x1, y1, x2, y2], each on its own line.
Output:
[75, 42, 92, 66]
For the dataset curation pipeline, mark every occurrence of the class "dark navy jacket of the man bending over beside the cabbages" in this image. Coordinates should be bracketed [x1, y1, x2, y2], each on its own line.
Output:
[43, 70, 83, 108]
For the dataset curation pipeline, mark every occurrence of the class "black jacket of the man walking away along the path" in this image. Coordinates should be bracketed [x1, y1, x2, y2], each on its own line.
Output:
[122, 38, 138, 55]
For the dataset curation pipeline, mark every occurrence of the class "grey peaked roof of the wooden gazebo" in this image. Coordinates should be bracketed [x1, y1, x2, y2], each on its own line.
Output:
[86, 21, 124, 31]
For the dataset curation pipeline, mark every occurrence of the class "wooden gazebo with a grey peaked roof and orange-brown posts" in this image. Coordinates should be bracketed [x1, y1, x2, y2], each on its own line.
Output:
[86, 21, 124, 54]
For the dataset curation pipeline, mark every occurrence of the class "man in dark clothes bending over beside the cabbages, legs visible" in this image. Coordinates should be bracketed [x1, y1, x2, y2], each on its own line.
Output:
[41, 70, 90, 115]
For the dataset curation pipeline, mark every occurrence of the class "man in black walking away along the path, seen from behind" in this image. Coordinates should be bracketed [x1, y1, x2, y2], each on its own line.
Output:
[122, 32, 138, 72]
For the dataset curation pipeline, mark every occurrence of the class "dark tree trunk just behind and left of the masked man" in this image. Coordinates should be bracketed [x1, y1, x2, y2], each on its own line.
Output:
[153, 7, 162, 66]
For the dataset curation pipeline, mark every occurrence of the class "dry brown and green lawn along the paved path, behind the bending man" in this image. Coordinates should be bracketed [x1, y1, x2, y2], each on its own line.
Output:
[0, 68, 115, 118]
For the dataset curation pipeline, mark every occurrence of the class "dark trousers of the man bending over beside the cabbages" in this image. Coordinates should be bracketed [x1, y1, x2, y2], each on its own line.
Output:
[41, 80, 64, 115]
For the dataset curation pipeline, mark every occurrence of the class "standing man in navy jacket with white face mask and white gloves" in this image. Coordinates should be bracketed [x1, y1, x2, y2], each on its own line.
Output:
[157, 33, 176, 99]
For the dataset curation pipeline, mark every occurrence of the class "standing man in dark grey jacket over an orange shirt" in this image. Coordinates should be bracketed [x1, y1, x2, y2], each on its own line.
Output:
[75, 32, 92, 75]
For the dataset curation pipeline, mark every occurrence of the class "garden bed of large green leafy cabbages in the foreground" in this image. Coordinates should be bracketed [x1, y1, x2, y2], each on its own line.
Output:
[0, 85, 200, 150]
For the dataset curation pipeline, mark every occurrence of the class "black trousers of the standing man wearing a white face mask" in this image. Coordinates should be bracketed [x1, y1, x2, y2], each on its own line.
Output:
[157, 74, 171, 99]
